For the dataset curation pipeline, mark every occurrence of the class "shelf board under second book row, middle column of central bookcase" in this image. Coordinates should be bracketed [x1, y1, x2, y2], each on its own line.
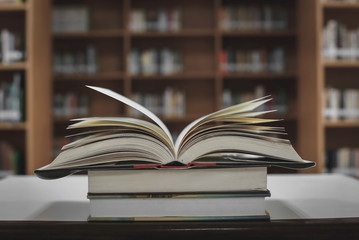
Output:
[131, 72, 215, 81]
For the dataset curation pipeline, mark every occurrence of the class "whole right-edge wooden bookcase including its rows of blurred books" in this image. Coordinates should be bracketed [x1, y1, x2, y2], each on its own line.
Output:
[299, 1, 359, 176]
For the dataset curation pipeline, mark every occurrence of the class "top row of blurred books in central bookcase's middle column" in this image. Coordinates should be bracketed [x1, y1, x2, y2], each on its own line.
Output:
[129, 9, 181, 32]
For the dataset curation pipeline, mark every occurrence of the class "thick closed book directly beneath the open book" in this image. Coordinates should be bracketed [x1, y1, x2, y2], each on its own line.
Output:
[88, 167, 267, 193]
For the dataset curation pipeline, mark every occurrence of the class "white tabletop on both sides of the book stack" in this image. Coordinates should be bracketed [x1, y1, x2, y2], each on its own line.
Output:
[0, 174, 359, 221]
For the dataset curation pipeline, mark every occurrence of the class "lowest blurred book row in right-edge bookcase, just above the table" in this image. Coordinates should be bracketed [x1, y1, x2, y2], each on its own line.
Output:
[325, 147, 359, 176]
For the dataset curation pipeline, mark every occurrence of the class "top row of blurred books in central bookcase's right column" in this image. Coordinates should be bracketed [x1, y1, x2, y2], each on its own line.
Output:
[220, 3, 288, 30]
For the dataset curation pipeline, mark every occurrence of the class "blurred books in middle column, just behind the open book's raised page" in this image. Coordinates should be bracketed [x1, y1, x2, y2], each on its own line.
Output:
[131, 87, 186, 117]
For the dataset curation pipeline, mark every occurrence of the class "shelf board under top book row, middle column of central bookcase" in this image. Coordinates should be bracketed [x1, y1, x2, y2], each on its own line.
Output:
[130, 29, 215, 38]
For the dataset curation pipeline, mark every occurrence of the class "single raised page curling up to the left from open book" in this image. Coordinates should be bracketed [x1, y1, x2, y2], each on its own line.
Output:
[86, 85, 174, 145]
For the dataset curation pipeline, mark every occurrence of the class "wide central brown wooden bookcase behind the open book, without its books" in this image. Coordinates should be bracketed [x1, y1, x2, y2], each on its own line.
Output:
[49, 0, 305, 172]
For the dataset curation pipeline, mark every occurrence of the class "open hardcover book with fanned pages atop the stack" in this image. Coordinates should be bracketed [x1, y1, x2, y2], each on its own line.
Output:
[35, 86, 315, 178]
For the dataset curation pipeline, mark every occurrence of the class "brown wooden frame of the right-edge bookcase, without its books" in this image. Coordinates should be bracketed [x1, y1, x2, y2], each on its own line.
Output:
[299, 0, 359, 172]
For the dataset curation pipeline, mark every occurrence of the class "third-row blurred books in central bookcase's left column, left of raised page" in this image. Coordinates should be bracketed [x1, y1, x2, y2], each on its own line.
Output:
[53, 92, 90, 118]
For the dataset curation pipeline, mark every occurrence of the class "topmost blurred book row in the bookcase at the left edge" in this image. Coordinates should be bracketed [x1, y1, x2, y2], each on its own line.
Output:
[0, 29, 25, 64]
